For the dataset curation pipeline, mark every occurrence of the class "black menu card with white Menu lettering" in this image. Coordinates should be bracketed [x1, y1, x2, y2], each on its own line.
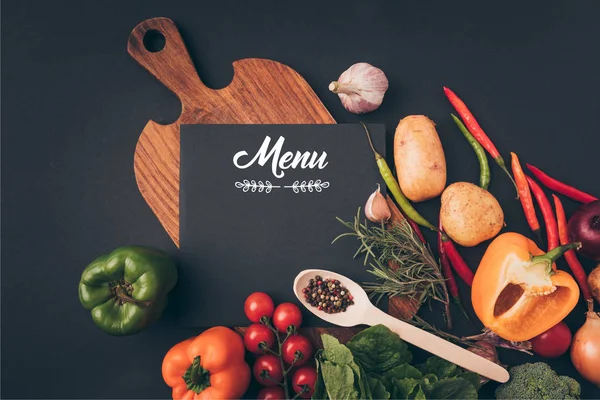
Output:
[177, 124, 385, 327]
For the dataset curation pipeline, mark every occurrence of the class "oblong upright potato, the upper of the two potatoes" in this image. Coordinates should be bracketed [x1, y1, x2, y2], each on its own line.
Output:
[394, 115, 446, 202]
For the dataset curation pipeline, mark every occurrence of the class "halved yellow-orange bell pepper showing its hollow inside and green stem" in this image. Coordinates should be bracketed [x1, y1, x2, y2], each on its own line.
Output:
[471, 232, 581, 341]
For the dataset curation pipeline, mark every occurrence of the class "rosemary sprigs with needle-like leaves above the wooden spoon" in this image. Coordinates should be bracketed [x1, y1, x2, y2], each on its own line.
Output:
[333, 208, 449, 310]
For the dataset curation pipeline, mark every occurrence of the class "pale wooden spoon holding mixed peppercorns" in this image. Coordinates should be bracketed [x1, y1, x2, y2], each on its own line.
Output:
[293, 269, 509, 383]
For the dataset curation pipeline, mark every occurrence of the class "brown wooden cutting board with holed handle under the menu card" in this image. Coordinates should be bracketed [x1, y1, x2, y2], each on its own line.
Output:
[127, 18, 418, 340]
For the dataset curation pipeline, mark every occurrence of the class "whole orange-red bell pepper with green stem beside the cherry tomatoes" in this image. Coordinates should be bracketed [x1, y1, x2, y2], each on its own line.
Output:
[162, 326, 250, 400]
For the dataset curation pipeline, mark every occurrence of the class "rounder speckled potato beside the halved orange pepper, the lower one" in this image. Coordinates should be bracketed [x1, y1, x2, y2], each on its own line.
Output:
[440, 182, 504, 247]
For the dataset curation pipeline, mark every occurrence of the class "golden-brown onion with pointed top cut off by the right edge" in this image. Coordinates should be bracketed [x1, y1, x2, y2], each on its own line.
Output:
[571, 300, 600, 386]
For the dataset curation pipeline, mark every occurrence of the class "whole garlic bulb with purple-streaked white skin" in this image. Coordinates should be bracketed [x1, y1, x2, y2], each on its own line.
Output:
[329, 63, 389, 114]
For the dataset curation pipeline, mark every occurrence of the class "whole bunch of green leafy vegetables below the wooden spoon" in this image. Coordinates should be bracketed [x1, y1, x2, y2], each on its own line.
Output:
[313, 325, 479, 400]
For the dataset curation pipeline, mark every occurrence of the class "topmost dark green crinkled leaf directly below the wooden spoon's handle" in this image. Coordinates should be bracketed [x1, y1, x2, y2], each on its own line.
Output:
[347, 325, 412, 374]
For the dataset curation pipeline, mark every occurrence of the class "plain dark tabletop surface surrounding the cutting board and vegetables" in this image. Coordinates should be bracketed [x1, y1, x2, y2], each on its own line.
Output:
[1, 0, 600, 398]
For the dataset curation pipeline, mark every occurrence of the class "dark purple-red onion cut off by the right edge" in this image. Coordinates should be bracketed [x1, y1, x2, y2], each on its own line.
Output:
[568, 200, 600, 261]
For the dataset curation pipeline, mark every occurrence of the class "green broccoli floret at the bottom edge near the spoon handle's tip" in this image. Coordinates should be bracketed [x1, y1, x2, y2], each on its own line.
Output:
[496, 362, 581, 400]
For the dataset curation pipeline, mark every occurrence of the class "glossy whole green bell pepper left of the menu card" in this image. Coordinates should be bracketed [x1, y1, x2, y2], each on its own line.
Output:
[79, 246, 177, 336]
